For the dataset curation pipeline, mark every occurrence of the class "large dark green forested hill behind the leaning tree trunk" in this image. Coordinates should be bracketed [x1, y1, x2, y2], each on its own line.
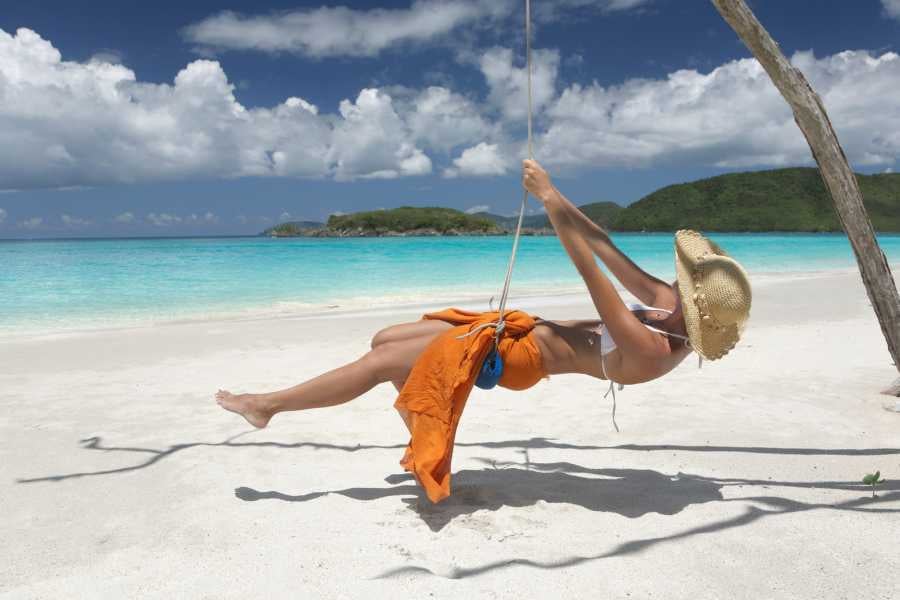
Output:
[612, 168, 900, 232]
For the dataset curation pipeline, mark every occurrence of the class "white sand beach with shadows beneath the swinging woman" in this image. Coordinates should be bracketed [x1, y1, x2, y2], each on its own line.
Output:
[0, 271, 900, 599]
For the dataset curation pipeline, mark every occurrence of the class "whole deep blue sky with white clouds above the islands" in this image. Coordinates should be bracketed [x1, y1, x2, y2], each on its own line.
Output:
[0, 0, 900, 238]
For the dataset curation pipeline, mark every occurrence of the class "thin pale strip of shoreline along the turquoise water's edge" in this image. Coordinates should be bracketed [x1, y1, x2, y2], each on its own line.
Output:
[0, 262, 884, 347]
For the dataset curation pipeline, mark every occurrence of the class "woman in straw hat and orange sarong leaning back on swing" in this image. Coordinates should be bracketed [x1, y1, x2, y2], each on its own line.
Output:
[216, 160, 751, 500]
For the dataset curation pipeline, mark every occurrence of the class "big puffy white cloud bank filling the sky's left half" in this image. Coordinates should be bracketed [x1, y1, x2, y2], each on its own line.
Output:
[0, 29, 431, 189]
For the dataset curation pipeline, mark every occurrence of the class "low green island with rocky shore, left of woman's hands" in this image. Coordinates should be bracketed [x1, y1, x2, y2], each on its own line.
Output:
[326, 206, 501, 235]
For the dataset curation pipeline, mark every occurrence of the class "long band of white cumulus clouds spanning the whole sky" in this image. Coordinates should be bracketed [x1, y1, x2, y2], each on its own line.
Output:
[0, 26, 900, 190]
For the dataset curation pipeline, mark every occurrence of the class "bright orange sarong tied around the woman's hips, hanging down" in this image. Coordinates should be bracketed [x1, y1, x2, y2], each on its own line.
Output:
[394, 308, 545, 502]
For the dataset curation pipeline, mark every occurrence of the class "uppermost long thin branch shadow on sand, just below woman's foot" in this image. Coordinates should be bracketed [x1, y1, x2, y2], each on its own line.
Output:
[16, 429, 900, 483]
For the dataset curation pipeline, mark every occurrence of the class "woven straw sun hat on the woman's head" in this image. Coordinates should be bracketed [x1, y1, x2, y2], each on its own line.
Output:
[675, 229, 752, 360]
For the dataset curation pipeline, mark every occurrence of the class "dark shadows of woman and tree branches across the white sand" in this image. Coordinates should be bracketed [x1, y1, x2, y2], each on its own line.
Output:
[17, 432, 900, 579]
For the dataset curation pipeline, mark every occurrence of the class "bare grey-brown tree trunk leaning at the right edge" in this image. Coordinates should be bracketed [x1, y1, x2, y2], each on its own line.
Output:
[712, 0, 900, 395]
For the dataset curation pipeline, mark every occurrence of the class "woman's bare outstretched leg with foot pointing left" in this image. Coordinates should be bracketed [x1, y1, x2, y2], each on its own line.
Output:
[216, 321, 449, 428]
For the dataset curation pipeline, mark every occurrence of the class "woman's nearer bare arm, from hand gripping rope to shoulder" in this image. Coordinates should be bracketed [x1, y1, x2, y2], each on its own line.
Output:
[523, 161, 669, 358]
